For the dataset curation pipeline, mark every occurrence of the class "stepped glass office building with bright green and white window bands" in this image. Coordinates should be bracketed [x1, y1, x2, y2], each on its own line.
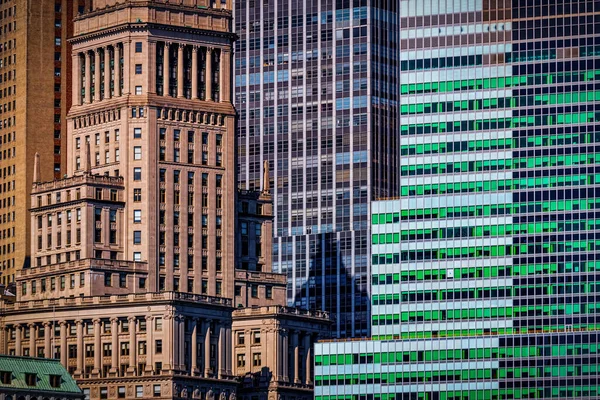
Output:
[316, 0, 600, 400]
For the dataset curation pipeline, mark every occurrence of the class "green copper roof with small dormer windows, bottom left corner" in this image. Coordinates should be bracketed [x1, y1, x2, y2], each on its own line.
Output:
[0, 355, 81, 393]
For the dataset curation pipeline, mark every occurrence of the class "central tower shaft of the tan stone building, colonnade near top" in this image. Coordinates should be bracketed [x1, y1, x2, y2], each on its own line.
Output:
[64, 0, 235, 298]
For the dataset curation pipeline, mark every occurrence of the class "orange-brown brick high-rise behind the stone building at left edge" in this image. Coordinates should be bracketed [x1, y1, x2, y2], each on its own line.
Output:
[0, 0, 89, 284]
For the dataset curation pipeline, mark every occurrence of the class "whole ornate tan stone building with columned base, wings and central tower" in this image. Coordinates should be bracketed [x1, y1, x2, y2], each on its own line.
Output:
[0, 0, 329, 400]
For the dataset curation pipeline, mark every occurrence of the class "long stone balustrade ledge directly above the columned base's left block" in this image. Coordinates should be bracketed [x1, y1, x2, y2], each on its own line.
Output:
[3, 292, 232, 313]
